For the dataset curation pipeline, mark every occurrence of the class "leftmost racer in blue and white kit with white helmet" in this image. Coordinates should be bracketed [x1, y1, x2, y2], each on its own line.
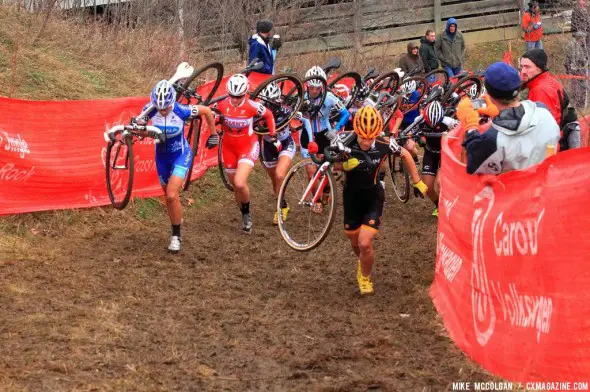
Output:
[135, 80, 215, 253]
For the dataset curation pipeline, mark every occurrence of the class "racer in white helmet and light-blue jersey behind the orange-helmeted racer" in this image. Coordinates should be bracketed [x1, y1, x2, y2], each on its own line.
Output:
[299, 65, 350, 213]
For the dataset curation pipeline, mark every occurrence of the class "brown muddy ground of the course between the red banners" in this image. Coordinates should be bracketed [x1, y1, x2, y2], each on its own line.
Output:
[0, 168, 494, 391]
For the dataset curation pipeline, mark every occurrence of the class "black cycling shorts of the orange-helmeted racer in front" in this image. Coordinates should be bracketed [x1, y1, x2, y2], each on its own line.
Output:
[342, 184, 385, 233]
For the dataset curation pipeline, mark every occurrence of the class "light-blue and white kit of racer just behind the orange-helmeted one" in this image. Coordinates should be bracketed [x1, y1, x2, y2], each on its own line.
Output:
[299, 91, 350, 158]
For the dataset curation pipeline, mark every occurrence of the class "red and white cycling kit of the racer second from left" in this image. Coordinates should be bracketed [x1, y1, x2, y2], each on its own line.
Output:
[217, 98, 276, 173]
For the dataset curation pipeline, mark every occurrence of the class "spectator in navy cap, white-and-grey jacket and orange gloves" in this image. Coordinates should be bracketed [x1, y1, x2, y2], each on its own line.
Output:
[457, 62, 559, 174]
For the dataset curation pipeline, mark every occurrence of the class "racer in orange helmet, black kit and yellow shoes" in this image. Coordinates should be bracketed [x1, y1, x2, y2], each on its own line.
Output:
[335, 106, 427, 295]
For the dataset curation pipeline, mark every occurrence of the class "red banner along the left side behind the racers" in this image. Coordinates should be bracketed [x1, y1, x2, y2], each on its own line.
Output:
[0, 73, 268, 215]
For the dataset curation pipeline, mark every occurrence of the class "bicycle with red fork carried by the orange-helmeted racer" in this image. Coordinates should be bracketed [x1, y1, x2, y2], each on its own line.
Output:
[277, 140, 380, 252]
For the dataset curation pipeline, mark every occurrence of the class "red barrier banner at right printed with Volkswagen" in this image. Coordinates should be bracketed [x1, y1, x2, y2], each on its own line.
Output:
[430, 130, 590, 382]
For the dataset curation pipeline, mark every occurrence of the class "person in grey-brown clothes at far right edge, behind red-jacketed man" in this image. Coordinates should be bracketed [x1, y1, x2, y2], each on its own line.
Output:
[564, 31, 590, 108]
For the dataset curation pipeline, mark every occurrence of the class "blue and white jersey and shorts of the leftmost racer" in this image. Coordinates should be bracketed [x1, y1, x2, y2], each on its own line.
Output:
[144, 102, 198, 185]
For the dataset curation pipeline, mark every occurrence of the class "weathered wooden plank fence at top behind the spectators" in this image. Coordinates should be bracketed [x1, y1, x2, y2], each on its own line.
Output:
[199, 0, 563, 60]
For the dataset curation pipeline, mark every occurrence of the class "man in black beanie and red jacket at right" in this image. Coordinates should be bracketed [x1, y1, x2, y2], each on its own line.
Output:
[520, 49, 580, 151]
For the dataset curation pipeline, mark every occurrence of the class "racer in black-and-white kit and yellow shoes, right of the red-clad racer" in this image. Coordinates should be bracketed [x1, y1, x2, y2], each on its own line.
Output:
[260, 83, 297, 225]
